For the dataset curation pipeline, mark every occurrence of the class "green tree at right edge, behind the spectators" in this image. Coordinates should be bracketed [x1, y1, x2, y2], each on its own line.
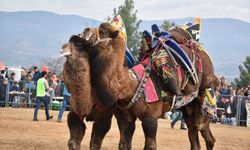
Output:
[235, 56, 250, 87]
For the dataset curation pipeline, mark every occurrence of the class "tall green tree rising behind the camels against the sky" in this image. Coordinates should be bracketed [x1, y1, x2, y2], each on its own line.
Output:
[109, 0, 141, 53]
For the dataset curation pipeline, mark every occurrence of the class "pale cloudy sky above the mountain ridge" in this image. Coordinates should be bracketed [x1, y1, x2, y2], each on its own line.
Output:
[0, 0, 250, 22]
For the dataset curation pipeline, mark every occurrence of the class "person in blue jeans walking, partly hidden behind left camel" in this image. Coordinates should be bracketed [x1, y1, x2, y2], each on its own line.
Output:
[57, 85, 71, 122]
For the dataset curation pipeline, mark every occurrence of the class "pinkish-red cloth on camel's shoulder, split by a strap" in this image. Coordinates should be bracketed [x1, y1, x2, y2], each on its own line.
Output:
[133, 64, 159, 103]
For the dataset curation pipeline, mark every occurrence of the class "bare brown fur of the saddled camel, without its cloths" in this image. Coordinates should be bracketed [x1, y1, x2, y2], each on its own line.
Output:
[82, 23, 217, 150]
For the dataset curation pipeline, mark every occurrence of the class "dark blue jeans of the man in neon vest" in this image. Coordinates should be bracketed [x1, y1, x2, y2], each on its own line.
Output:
[33, 96, 49, 120]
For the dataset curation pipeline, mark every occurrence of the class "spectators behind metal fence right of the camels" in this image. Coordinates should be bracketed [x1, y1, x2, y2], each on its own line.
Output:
[215, 77, 250, 125]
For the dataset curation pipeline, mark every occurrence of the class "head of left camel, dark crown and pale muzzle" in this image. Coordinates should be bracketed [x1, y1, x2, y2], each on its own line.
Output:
[61, 35, 90, 59]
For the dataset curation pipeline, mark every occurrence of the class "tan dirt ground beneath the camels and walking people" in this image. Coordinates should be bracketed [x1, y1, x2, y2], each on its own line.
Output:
[0, 108, 250, 150]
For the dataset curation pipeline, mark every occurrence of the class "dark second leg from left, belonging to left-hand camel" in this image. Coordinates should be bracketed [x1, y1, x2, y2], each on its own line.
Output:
[90, 111, 113, 150]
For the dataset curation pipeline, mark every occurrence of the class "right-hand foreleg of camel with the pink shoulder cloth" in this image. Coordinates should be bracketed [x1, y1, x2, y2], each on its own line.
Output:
[142, 117, 158, 150]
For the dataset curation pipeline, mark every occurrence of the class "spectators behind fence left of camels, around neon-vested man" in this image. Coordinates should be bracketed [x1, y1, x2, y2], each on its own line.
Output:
[0, 66, 64, 107]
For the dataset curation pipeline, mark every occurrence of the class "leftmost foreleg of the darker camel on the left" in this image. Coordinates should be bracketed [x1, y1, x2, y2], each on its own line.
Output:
[68, 112, 86, 150]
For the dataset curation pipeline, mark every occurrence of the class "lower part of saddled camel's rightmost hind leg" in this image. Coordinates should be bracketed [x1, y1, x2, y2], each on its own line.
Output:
[200, 124, 216, 150]
